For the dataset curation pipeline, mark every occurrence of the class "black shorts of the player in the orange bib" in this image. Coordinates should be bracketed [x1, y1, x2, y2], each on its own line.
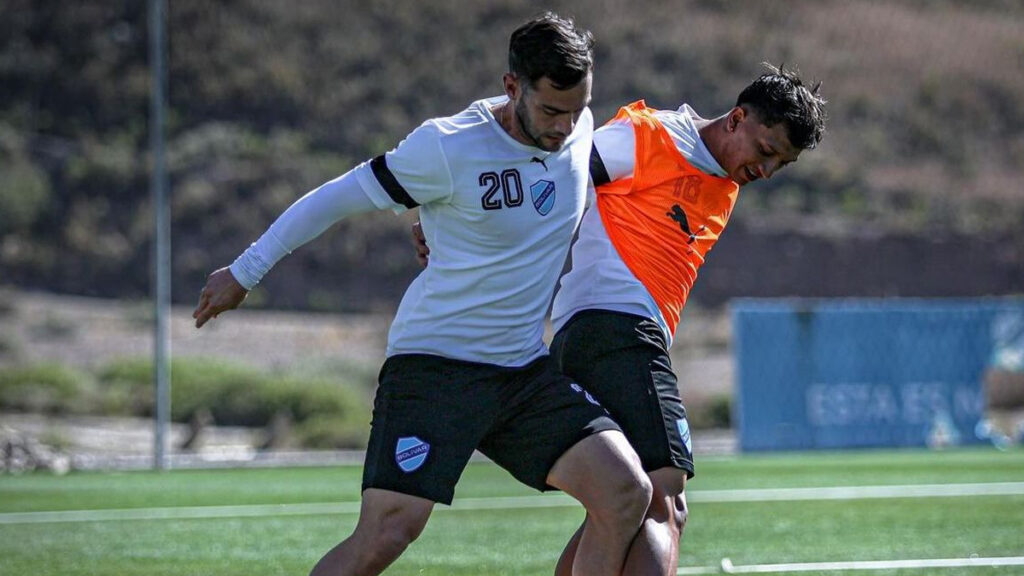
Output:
[551, 310, 693, 478]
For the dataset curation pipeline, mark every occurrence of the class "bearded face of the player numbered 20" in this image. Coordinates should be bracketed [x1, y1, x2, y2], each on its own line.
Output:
[506, 74, 593, 152]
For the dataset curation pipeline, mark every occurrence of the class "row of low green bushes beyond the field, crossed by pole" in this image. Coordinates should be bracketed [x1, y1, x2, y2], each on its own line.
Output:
[0, 359, 370, 449]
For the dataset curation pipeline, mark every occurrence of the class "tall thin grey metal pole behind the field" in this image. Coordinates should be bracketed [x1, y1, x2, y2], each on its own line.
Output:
[150, 0, 171, 470]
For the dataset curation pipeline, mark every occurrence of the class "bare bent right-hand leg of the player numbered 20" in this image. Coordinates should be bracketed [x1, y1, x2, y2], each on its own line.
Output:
[548, 430, 651, 576]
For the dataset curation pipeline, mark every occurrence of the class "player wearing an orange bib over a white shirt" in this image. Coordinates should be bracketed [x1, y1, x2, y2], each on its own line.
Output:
[414, 63, 824, 576]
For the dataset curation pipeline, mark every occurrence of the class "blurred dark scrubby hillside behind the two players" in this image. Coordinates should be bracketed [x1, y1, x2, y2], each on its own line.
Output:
[0, 0, 1024, 311]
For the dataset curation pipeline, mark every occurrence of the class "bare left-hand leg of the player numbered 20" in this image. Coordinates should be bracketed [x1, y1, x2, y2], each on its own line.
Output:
[309, 488, 434, 576]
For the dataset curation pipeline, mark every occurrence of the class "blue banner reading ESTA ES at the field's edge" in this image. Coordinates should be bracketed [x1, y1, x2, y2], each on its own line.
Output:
[732, 299, 1024, 451]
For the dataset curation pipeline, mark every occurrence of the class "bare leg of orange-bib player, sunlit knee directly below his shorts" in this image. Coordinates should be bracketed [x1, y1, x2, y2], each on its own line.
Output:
[623, 467, 686, 576]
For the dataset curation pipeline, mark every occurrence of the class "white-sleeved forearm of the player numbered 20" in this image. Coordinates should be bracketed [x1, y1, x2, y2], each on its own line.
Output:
[230, 170, 377, 290]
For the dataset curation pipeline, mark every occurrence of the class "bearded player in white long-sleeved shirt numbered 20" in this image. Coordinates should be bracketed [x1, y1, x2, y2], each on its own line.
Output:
[193, 13, 651, 576]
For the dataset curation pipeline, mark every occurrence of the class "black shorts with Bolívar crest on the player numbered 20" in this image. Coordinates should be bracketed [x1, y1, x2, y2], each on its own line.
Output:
[362, 355, 620, 504]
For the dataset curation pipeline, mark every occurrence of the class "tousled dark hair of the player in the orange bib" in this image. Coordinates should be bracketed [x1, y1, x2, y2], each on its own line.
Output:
[736, 64, 825, 150]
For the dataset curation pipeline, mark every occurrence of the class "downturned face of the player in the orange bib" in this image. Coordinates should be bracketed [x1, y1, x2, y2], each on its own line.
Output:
[718, 108, 801, 186]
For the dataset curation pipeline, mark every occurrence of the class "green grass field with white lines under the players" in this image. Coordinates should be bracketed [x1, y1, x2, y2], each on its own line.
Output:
[0, 449, 1024, 576]
